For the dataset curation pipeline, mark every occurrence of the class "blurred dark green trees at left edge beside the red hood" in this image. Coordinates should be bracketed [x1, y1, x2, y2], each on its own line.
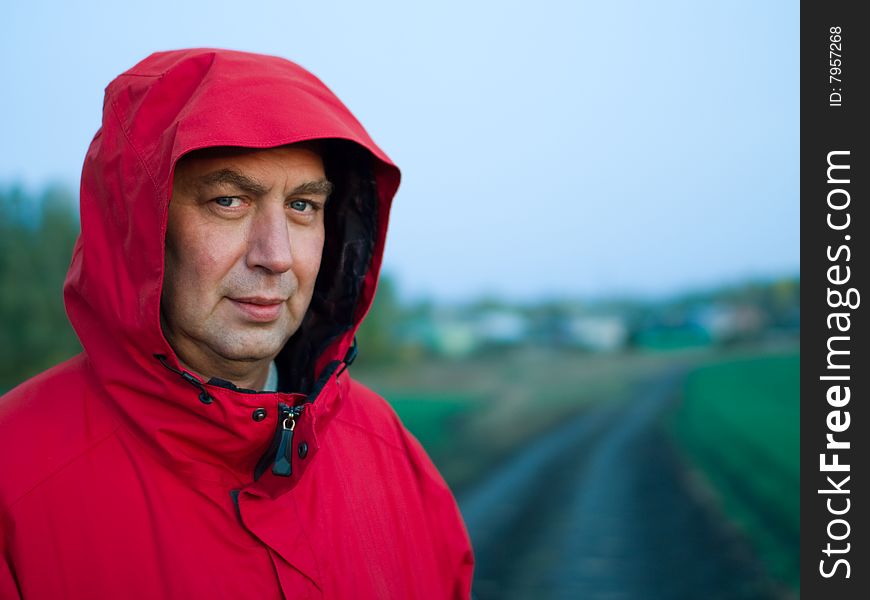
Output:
[0, 186, 81, 392]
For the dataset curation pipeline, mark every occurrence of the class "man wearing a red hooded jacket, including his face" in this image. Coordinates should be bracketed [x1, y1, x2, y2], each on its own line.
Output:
[0, 50, 472, 599]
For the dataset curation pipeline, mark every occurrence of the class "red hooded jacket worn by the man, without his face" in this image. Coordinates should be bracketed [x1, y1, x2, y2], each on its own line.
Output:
[0, 50, 472, 599]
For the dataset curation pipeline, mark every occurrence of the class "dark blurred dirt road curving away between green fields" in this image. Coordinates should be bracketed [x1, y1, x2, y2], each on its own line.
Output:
[459, 369, 780, 600]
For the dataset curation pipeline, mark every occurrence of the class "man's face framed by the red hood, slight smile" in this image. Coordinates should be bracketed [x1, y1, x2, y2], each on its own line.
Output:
[161, 145, 331, 372]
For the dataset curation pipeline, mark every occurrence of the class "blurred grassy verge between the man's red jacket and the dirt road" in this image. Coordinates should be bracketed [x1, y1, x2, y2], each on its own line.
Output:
[353, 348, 709, 493]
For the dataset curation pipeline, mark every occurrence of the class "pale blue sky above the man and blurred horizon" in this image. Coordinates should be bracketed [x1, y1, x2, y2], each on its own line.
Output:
[0, 0, 800, 300]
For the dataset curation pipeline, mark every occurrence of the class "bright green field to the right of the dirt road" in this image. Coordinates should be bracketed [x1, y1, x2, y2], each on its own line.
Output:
[668, 352, 800, 589]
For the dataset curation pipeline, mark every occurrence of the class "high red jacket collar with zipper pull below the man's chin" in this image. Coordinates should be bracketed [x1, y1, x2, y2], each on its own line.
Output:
[101, 358, 346, 486]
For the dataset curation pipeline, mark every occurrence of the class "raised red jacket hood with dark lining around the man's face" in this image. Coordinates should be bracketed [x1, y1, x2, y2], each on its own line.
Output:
[64, 49, 399, 483]
